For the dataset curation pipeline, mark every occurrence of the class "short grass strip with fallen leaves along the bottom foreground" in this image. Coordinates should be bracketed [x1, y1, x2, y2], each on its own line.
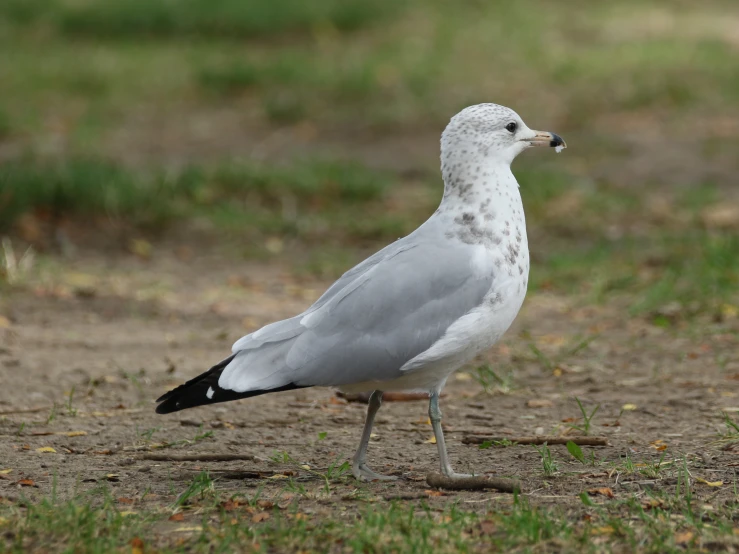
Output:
[0, 478, 734, 553]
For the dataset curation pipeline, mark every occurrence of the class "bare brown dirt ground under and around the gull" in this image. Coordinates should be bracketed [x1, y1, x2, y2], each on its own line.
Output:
[0, 247, 739, 536]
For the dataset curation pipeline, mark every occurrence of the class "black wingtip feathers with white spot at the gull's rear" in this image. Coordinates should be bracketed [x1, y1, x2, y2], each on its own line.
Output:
[156, 354, 303, 414]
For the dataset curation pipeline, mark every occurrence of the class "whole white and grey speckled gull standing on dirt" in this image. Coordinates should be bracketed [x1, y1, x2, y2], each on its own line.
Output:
[156, 104, 566, 481]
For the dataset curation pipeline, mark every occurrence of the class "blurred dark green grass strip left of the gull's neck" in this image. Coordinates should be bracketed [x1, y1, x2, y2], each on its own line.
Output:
[0, 159, 413, 243]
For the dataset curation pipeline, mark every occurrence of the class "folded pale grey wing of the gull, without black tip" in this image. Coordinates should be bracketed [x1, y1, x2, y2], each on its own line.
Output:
[219, 236, 493, 392]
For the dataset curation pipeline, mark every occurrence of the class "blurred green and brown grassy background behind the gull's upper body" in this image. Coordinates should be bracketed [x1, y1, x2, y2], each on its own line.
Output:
[0, 0, 739, 325]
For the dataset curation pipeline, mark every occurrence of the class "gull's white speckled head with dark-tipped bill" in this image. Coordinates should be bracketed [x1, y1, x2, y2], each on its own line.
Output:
[441, 104, 567, 164]
